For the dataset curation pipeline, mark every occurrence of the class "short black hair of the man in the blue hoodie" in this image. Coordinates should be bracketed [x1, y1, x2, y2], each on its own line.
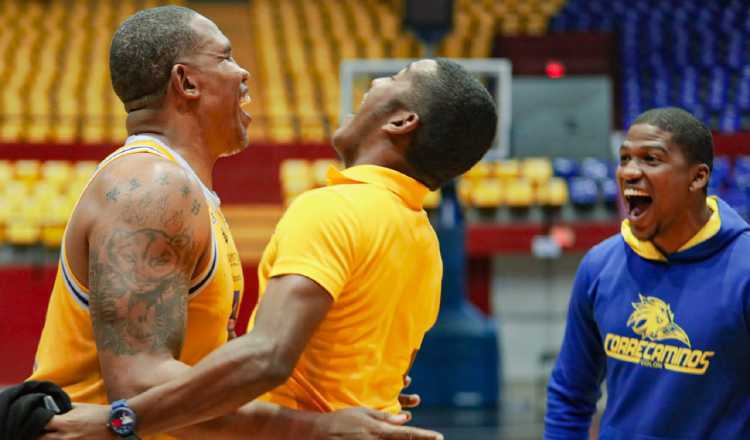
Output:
[633, 107, 714, 170]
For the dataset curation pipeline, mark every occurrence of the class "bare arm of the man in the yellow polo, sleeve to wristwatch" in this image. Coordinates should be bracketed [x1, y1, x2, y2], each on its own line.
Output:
[129, 275, 333, 435]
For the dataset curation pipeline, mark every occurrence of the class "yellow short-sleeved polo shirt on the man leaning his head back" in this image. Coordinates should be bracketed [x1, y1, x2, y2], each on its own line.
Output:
[249, 165, 443, 413]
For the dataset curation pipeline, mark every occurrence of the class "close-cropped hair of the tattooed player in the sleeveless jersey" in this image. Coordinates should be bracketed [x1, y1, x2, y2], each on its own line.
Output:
[109, 6, 198, 110]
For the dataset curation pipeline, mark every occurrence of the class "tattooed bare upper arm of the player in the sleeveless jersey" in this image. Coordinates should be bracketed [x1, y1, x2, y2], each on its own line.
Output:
[86, 157, 210, 401]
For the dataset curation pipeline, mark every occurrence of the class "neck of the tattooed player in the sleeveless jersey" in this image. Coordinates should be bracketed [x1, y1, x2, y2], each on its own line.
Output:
[126, 109, 218, 189]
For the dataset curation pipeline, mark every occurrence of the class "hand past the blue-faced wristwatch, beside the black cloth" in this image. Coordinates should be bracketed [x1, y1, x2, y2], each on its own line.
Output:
[41, 403, 111, 440]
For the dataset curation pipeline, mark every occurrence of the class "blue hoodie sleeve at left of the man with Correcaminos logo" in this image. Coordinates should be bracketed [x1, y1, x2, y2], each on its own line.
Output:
[544, 253, 606, 440]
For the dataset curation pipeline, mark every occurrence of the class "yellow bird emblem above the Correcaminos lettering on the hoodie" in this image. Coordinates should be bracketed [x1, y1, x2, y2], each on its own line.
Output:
[627, 294, 690, 347]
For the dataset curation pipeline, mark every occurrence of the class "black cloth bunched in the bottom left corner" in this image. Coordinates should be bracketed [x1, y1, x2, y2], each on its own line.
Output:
[0, 381, 72, 440]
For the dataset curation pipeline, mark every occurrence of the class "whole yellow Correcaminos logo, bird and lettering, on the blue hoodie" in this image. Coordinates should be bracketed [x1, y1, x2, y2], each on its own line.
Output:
[604, 294, 715, 375]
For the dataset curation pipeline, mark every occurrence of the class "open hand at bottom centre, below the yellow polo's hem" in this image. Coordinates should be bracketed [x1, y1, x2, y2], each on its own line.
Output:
[312, 408, 443, 440]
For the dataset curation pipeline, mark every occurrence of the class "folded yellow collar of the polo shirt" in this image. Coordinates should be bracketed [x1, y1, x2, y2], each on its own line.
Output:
[327, 165, 430, 209]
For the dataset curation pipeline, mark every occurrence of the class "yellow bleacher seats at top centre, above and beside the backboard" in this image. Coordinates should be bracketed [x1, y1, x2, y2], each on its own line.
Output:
[250, 0, 563, 142]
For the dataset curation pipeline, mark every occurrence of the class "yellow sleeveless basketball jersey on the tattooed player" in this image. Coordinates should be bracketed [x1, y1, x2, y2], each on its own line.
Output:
[29, 135, 244, 438]
